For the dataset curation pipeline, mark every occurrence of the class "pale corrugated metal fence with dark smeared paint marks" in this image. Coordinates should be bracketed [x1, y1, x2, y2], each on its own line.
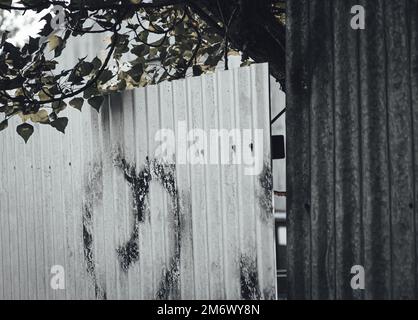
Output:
[0, 65, 276, 299]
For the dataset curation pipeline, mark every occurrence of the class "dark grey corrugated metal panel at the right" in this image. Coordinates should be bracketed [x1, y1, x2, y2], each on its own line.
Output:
[287, 0, 418, 299]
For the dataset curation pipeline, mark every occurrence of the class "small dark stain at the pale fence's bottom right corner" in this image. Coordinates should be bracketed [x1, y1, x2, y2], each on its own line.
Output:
[240, 255, 261, 300]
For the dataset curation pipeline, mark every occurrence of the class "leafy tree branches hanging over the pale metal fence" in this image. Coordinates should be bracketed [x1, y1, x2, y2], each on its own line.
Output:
[0, 0, 284, 141]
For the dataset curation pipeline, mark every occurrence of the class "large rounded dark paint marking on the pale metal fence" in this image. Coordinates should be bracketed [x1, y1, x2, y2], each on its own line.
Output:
[83, 151, 182, 299]
